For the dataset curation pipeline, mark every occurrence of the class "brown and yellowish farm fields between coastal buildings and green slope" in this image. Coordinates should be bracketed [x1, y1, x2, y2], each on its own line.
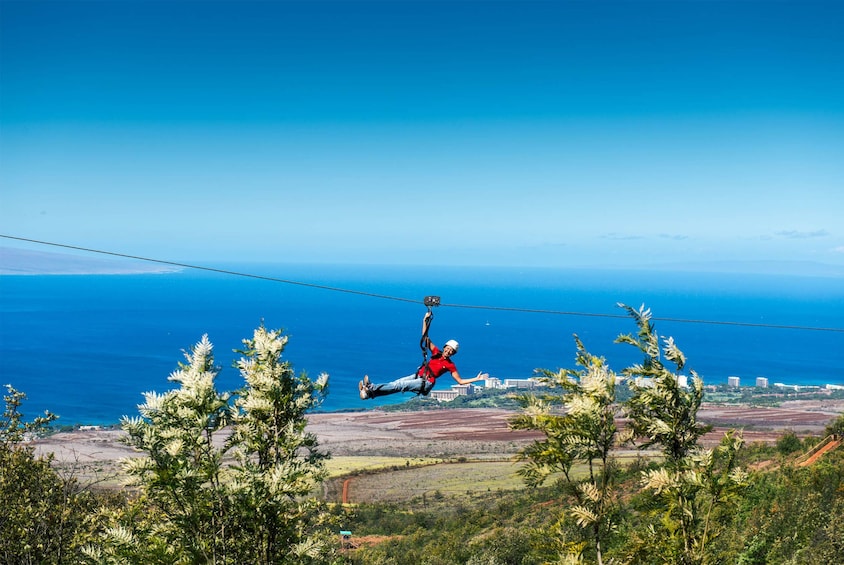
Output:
[34, 399, 844, 501]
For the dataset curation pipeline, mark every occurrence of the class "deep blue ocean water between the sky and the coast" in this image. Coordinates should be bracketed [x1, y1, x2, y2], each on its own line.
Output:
[0, 265, 844, 424]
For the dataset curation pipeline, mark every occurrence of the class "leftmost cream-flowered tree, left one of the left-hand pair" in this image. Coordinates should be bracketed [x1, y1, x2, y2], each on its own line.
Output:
[97, 335, 232, 563]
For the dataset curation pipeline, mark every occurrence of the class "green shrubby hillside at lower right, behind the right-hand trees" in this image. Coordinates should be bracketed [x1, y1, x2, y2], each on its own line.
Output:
[345, 440, 844, 565]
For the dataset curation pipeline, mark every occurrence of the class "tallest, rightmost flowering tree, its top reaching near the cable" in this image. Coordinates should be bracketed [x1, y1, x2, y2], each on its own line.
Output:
[617, 304, 747, 565]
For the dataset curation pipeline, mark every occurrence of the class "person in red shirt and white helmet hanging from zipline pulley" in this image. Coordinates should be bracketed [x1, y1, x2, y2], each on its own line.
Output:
[358, 296, 489, 400]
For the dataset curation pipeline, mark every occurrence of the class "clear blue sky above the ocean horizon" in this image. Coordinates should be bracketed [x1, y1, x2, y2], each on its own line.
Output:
[0, 0, 844, 266]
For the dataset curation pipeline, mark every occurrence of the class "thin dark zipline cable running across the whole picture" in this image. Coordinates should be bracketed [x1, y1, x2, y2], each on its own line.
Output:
[0, 234, 844, 333]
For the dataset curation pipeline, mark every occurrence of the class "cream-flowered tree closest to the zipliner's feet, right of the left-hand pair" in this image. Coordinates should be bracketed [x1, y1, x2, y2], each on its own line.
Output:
[227, 326, 335, 564]
